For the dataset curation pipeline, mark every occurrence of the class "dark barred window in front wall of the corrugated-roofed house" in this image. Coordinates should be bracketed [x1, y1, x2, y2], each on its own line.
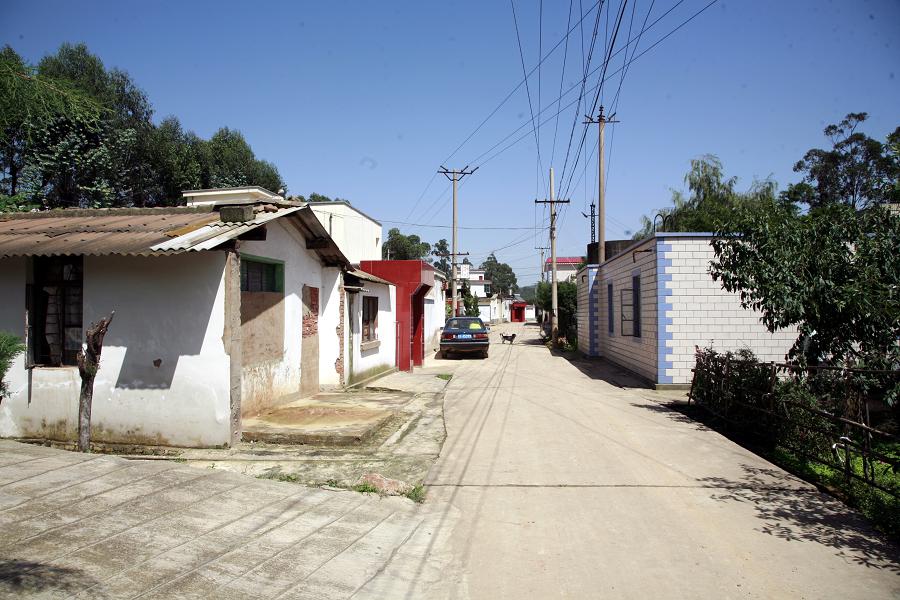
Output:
[26, 256, 84, 367]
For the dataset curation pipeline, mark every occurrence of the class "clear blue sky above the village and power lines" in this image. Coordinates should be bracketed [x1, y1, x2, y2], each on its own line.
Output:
[0, 0, 900, 283]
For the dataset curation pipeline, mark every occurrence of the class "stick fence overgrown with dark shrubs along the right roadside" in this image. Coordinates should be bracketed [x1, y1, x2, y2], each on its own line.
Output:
[689, 349, 900, 500]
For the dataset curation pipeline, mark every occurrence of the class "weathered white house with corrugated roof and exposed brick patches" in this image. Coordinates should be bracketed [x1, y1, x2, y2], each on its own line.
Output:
[0, 188, 351, 446]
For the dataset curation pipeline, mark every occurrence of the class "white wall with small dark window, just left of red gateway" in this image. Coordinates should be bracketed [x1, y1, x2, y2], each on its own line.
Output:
[348, 281, 397, 383]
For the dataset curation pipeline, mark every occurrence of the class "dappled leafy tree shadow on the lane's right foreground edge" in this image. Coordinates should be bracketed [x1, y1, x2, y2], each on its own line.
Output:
[698, 464, 900, 574]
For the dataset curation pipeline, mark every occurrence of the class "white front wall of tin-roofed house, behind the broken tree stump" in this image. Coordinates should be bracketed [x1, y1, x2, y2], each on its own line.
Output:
[0, 252, 236, 446]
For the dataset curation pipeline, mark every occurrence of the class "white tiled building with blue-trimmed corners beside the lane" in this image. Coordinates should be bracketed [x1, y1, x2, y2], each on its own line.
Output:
[576, 233, 797, 386]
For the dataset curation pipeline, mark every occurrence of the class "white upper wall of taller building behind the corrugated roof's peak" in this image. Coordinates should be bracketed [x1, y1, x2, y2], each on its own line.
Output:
[309, 202, 384, 264]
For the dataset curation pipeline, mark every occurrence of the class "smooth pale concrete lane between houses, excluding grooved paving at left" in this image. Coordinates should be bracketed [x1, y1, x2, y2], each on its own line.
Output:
[406, 326, 900, 600]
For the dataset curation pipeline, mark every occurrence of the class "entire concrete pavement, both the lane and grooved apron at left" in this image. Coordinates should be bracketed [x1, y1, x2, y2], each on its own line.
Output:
[0, 326, 900, 600]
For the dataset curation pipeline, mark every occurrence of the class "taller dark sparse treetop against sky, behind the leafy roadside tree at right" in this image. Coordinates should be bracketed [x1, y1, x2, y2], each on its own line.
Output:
[784, 112, 900, 209]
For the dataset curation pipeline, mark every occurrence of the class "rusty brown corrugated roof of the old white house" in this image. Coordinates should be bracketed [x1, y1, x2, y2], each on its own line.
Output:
[0, 205, 349, 267]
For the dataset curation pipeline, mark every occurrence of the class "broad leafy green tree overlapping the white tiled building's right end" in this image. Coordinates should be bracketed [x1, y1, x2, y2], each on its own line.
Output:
[710, 195, 900, 365]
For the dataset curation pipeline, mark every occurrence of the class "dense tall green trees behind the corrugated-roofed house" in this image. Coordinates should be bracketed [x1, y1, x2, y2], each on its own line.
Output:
[0, 44, 284, 210]
